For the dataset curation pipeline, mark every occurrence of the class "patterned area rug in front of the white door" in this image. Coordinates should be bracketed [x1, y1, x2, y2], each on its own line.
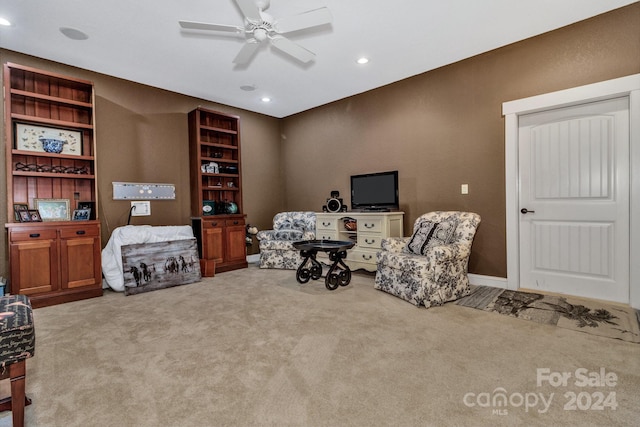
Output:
[456, 286, 640, 343]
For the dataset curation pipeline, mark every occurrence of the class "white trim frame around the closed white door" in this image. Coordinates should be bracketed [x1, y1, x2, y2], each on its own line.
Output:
[502, 74, 640, 309]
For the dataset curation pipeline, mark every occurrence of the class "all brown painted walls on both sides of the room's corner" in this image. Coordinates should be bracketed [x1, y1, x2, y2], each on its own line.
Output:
[0, 3, 640, 277]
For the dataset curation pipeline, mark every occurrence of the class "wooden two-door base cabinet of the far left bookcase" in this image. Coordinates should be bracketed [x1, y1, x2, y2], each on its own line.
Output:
[7, 221, 102, 307]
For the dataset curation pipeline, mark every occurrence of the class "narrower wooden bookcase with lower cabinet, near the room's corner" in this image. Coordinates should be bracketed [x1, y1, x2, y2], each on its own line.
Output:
[189, 108, 247, 276]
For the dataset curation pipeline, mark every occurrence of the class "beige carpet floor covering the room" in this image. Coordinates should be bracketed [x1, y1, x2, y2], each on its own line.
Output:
[0, 265, 640, 427]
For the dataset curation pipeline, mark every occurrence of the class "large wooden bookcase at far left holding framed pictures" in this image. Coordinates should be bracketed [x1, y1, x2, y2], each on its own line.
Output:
[3, 63, 102, 307]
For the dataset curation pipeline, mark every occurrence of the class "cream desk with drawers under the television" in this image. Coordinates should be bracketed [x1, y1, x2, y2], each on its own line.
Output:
[316, 212, 404, 271]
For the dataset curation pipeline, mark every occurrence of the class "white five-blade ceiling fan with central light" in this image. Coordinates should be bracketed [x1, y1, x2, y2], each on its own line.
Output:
[178, 0, 332, 65]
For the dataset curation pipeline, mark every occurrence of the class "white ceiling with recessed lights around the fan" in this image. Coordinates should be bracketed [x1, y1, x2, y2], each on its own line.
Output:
[0, 0, 637, 117]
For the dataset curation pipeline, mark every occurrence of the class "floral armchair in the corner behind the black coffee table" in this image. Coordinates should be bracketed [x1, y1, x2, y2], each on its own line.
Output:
[256, 212, 316, 270]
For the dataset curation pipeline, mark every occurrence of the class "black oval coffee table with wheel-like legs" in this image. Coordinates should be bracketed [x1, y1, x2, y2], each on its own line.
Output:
[293, 240, 355, 291]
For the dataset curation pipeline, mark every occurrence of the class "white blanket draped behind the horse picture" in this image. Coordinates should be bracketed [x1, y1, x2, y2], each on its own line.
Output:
[102, 225, 194, 292]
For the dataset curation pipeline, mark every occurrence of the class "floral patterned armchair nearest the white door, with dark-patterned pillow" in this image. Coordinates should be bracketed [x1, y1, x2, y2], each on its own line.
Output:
[374, 211, 480, 308]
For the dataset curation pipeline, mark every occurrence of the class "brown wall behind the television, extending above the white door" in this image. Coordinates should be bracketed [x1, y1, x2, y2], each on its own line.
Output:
[283, 3, 640, 277]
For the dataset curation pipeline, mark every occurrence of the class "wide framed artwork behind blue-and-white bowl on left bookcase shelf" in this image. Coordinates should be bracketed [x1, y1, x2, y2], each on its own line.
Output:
[15, 123, 82, 156]
